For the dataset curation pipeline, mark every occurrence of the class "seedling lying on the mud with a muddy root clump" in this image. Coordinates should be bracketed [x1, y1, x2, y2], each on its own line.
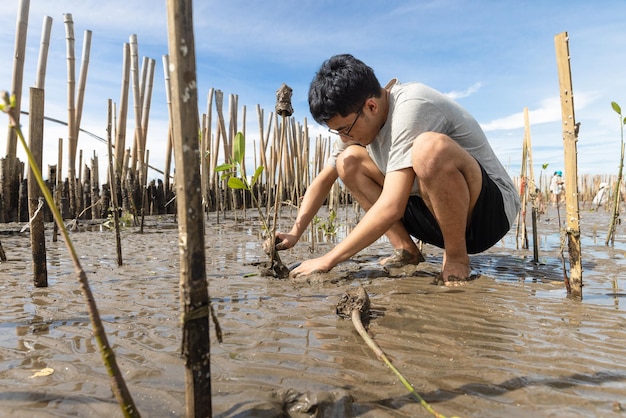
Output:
[337, 286, 454, 418]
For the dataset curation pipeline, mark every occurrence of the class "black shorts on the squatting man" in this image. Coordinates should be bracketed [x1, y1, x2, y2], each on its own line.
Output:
[402, 167, 511, 254]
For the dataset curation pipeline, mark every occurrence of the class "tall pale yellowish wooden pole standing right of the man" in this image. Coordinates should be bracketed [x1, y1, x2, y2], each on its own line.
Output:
[554, 32, 582, 298]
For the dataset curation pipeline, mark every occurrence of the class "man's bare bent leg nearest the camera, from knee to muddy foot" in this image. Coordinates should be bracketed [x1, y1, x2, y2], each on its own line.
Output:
[412, 132, 482, 282]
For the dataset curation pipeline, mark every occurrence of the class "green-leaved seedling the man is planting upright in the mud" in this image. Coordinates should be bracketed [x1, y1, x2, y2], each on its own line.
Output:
[215, 132, 269, 231]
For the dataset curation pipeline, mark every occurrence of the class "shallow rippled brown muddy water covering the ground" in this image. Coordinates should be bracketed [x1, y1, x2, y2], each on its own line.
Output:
[0, 208, 626, 417]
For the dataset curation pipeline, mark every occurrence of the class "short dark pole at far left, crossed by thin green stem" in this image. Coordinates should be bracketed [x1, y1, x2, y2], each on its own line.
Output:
[28, 87, 48, 287]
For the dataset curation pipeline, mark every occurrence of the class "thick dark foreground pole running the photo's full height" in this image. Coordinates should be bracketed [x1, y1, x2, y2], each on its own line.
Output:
[167, 0, 212, 417]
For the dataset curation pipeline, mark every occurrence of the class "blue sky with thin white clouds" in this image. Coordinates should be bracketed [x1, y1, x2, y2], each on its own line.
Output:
[0, 0, 626, 183]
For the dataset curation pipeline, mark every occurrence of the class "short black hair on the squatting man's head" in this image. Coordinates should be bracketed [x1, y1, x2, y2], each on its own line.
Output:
[309, 54, 381, 125]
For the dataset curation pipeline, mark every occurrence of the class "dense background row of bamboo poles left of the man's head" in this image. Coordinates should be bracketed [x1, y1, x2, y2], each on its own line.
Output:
[0, 0, 346, 227]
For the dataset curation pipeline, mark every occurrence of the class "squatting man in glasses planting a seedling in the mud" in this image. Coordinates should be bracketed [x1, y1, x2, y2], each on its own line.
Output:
[276, 55, 520, 286]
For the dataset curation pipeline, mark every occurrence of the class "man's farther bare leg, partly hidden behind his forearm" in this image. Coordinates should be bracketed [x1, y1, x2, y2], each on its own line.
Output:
[337, 145, 423, 264]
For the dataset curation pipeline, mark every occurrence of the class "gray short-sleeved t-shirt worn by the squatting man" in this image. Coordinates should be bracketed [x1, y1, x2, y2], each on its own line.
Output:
[328, 80, 520, 225]
